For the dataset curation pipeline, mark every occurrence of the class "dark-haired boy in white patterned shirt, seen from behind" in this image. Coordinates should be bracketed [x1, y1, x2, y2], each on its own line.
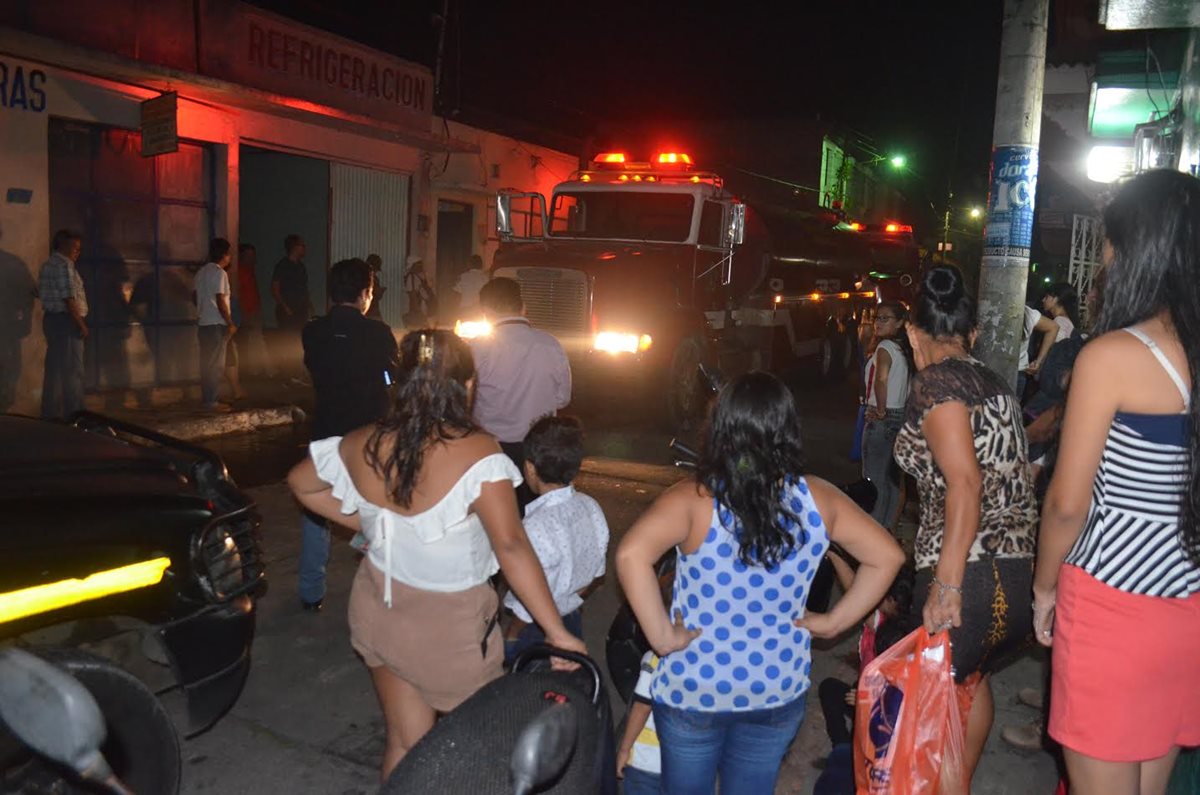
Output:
[504, 417, 608, 664]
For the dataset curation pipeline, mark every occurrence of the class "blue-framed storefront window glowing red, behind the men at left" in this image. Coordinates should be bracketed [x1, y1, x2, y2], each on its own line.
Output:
[49, 119, 214, 389]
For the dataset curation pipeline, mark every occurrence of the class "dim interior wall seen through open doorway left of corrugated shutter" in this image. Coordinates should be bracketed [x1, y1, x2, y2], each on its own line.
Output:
[238, 147, 330, 327]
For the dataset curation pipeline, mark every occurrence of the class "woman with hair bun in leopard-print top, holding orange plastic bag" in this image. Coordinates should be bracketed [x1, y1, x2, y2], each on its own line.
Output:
[895, 265, 1038, 782]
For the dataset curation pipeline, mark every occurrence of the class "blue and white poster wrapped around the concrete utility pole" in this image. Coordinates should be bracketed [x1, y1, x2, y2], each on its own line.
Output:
[983, 145, 1038, 264]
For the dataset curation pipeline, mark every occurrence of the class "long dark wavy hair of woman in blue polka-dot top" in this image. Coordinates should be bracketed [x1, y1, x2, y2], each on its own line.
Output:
[696, 372, 808, 568]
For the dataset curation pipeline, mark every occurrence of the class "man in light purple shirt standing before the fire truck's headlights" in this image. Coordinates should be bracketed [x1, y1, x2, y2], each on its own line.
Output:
[470, 277, 571, 510]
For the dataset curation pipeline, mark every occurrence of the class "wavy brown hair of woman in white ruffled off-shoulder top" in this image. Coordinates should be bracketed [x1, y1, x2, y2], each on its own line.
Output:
[366, 329, 479, 508]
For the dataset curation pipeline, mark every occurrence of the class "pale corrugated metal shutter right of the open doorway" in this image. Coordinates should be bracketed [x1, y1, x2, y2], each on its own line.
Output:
[329, 163, 409, 328]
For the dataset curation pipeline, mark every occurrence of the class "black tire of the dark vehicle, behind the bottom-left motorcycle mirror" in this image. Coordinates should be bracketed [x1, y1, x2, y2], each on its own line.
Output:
[0, 648, 181, 795]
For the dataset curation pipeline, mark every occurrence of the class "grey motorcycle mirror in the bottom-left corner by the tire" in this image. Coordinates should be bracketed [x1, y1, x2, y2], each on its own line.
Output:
[0, 648, 113, 781]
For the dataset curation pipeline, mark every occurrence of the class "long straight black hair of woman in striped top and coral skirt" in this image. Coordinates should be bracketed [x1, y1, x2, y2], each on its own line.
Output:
[1096, 169, 1200, 563]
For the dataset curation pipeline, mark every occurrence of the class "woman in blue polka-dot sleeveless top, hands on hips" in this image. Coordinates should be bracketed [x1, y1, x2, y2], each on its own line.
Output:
[617, 372, 904, 795]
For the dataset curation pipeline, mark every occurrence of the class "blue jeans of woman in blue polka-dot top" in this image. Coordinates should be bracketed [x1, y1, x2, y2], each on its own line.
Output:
[654, 695, 805, 795]
